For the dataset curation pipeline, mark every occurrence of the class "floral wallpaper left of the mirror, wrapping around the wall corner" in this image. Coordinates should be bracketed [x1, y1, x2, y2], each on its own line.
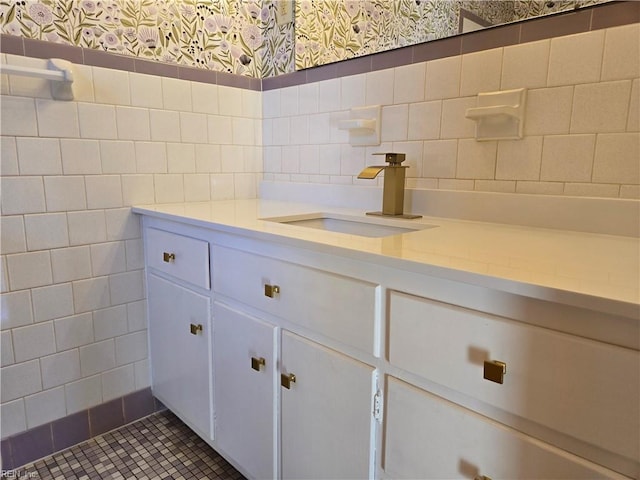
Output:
[0, 0, 294, 78]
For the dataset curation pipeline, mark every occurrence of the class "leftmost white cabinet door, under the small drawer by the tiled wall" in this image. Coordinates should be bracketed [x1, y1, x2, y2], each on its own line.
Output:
[148, 275, 212, 439]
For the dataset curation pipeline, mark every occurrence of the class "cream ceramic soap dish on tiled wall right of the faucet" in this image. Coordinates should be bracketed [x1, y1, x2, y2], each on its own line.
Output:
[465, 88, 527, 141]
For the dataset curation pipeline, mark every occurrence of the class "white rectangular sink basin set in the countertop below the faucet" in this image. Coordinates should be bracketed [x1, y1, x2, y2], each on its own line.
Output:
[262, 213, 437, 237]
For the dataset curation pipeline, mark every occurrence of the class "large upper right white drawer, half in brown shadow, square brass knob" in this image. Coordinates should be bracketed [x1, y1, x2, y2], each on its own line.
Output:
[389, 292, 640, 461]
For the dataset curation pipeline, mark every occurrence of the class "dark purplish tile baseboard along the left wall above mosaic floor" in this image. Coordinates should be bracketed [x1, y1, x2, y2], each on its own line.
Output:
[1, 388, 166, 472]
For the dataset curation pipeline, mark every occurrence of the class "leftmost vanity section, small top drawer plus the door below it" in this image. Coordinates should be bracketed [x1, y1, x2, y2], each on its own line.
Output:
[145, 228, 213, 440]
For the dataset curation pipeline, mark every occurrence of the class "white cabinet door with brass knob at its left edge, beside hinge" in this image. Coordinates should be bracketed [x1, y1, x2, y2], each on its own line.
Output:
[281, 331, 373, 479]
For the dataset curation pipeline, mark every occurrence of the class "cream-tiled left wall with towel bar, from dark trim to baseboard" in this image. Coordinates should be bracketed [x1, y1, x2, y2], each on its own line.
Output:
[0, 54, 260, 438]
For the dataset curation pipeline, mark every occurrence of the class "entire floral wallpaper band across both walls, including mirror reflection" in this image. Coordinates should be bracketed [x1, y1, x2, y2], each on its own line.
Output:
[0, 0, 610, 78]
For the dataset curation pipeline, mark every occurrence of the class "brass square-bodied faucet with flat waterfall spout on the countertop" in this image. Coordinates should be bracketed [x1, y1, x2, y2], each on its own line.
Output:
[358, 153, 422, 218]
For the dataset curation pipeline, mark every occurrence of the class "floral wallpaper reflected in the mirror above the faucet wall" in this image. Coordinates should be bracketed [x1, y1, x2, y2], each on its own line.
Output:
[295, 0, 609, 70]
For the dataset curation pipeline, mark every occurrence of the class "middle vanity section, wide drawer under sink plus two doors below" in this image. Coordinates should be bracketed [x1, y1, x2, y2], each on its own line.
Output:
[212, 242, 376, 479]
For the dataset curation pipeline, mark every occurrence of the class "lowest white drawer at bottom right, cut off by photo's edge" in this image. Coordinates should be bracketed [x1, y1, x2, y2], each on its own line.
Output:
[383, 377, 623, 480]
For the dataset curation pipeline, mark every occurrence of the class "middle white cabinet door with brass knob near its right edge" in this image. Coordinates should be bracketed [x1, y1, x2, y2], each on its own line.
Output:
[213, 303, 276, 478]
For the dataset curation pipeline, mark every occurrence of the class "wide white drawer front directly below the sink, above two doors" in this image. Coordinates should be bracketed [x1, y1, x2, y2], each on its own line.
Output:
[212, 245, 376, 352]
